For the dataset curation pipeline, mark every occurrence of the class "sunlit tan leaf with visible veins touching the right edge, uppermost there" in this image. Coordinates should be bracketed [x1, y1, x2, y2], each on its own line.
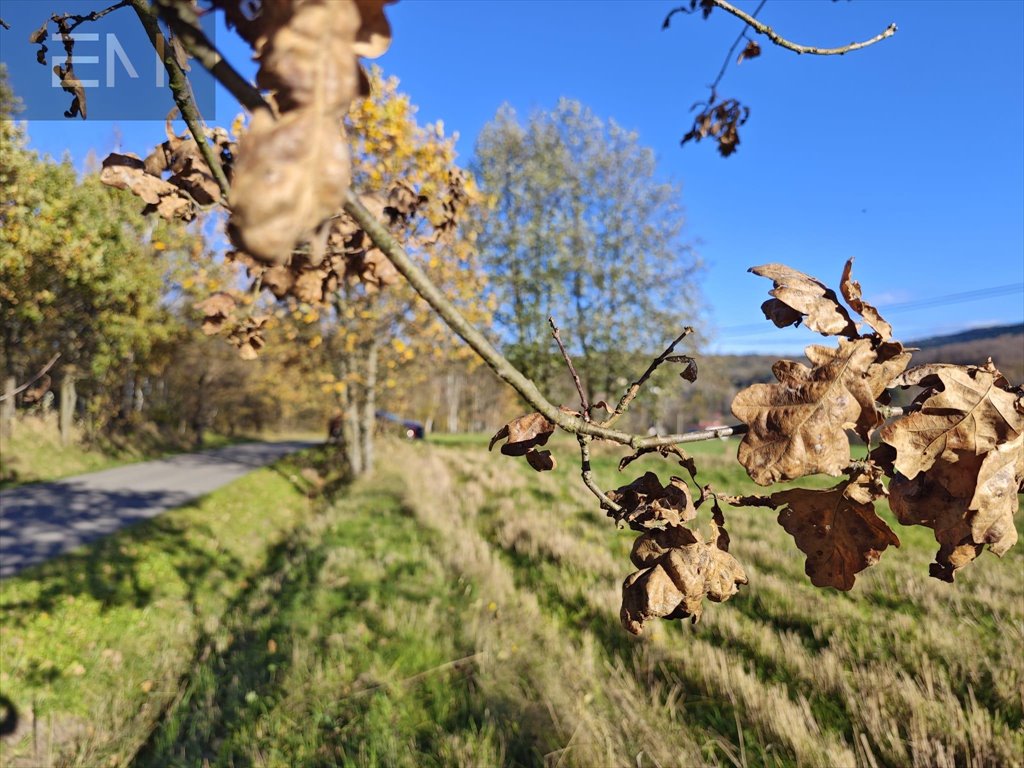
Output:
[882, 366, 1024, 477]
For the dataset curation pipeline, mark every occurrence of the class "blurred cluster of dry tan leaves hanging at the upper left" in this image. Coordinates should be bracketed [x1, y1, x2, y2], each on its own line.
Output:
[97, 0, 468, 359]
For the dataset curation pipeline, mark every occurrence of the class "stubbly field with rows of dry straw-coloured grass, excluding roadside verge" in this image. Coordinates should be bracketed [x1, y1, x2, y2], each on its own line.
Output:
[2, 442, 1024, 768]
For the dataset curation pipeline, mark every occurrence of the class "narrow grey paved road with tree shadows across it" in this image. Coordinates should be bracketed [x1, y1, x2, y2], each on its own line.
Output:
[0, 440, 316, 579]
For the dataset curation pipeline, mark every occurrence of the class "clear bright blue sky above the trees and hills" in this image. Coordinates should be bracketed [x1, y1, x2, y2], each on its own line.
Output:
[0, 0, 1024, 353]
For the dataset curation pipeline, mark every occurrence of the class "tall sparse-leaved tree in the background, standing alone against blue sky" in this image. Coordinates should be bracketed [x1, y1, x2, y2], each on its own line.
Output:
[473, 99, 699, 401]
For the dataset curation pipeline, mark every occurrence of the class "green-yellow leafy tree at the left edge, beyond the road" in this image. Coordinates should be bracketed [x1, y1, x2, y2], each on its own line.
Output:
[0, 64, 191, 438]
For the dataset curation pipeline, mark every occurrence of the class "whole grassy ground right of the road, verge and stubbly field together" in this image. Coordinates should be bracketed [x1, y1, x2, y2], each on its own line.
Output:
[0, 439, 1024, 768]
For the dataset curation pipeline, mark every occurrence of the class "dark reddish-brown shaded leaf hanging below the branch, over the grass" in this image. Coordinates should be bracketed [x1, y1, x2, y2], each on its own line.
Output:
[771, 474, 899, 591]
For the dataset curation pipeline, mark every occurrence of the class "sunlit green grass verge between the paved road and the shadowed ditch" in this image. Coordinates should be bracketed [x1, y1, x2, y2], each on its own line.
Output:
[0, 448, 344, 766]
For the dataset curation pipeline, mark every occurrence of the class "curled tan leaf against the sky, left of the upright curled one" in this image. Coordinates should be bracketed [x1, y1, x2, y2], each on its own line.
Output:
[748, 264, 857, 339]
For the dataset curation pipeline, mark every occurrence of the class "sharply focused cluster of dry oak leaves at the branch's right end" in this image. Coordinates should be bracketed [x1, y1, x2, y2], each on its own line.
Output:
[492, 259, 1024, 634]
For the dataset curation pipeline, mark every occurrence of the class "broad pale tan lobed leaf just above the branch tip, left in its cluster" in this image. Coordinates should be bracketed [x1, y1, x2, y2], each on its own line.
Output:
[732, 339, 878, 485]
